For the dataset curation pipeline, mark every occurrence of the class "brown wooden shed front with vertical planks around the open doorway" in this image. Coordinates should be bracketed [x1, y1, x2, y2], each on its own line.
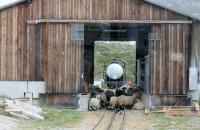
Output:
[0, 0, 200, 106]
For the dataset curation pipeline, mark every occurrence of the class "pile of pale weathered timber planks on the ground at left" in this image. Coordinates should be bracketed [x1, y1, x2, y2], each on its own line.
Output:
[0, 99, 44, 120]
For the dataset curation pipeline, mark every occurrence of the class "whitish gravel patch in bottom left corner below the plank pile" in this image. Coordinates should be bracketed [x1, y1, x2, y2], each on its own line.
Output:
[0, 115, 18, 130]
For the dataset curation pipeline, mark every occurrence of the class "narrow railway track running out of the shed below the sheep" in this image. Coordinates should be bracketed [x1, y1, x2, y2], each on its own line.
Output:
[91, 110, 126, 130]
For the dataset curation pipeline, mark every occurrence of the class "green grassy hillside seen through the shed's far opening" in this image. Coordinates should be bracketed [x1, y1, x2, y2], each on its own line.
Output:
[94, 41, 136, 81]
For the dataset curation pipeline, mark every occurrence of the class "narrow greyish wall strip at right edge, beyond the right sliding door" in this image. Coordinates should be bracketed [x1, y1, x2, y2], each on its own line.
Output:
[190, 23, 200, 81]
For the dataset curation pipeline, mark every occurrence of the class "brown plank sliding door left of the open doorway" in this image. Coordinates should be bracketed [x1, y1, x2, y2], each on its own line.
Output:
[27, 23, 84, 106]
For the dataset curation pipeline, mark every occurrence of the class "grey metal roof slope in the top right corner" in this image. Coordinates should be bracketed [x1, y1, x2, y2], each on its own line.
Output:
[144, 0, 200, 20]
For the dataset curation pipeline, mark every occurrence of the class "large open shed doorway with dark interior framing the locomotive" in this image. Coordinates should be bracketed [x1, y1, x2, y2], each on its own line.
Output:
[84, 23, 151, 91]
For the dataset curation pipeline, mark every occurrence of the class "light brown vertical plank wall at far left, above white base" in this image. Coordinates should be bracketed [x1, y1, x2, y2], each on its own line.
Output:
[0, 4, 29, 80]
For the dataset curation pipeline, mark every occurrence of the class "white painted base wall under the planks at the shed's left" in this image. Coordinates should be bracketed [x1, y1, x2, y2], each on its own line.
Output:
[0, 81, 46, 98]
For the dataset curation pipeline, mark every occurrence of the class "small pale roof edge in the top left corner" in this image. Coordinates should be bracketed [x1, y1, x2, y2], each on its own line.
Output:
[0, 0, 26, 10]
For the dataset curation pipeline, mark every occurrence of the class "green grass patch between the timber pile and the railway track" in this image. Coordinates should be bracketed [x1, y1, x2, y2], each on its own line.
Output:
[20, 107, 83, 130]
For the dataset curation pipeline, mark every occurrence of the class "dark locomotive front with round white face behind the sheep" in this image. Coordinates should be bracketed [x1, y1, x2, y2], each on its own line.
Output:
[103, 59, 126, 89]
